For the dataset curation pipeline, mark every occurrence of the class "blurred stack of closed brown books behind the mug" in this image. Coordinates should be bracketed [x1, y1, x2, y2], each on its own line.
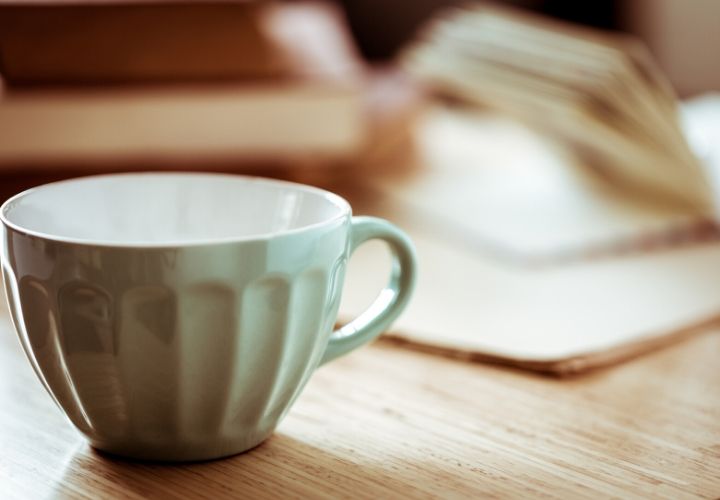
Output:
[0, 0, 366, 170]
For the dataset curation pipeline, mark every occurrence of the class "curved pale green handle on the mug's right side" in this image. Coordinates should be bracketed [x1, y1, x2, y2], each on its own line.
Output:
[320, 217, 417, 365]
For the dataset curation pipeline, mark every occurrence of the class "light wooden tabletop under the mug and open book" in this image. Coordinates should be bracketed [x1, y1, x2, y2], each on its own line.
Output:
[0, 298, 720, 499]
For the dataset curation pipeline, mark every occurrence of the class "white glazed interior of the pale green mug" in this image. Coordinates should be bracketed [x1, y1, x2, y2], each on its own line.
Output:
[0, 173, 350, 246]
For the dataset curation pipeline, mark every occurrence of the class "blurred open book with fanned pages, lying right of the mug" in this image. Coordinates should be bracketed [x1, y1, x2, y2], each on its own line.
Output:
[341, 7, 720, 374]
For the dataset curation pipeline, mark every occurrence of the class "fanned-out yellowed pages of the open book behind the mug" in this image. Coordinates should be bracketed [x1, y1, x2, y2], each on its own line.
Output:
[403, 5, 713, 214]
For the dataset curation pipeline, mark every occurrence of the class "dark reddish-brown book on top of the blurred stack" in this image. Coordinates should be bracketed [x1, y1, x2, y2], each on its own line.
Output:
[0, 0, 284, 85]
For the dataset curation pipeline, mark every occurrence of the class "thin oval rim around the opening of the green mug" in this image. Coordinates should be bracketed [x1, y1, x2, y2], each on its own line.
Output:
[0, 171, 352, 250]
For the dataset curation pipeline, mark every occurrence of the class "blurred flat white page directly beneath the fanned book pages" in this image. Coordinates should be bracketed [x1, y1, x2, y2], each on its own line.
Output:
[367, 108, 704, 261]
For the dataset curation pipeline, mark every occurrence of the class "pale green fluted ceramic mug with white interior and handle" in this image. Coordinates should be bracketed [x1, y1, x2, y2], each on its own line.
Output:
[0, 173, 416, 460]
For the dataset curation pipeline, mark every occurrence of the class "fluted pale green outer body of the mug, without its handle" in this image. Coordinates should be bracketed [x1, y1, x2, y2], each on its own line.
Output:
[2, 174, 416, 460]
